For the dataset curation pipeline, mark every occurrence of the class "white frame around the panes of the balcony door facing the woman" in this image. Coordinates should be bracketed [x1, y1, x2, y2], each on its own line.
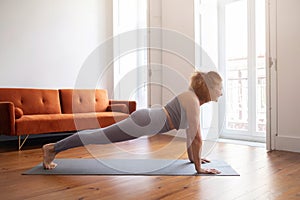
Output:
[218, 0, 266, 142]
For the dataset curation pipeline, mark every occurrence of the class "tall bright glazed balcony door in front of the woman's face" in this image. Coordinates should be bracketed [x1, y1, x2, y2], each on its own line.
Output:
[219, 0, 266, 141]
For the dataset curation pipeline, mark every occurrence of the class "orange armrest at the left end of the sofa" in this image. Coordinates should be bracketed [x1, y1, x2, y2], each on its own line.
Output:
[0, 102, 15, 135]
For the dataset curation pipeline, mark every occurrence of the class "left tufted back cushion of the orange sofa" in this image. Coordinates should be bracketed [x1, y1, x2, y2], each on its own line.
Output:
[0, 88, 61, 115]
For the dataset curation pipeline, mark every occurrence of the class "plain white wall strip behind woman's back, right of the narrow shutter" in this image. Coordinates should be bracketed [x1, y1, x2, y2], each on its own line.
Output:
[161, 0, 195, 104]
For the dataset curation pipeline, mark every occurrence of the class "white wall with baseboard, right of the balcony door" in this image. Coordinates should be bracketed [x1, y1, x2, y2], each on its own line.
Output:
[269, 0, 300, 152]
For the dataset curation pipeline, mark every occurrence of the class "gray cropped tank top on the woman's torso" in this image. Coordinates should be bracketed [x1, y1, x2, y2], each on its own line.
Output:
[165, 97, 187, 130]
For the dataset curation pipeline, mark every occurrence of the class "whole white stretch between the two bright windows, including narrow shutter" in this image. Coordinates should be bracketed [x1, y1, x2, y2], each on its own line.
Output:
[148, 0, 195, 106]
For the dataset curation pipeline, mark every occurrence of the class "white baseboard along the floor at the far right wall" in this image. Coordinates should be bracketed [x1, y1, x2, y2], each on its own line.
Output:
[275, 136, 300, 153]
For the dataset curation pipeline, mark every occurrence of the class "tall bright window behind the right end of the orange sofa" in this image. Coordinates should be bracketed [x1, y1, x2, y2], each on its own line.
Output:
[113, 0, 147, 108]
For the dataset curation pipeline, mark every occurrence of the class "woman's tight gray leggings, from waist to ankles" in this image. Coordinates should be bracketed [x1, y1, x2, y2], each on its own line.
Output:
[54, 108, 170, 153]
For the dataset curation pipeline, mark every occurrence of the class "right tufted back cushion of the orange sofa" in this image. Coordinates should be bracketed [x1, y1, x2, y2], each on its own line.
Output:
[59, 89, 109, 113]
